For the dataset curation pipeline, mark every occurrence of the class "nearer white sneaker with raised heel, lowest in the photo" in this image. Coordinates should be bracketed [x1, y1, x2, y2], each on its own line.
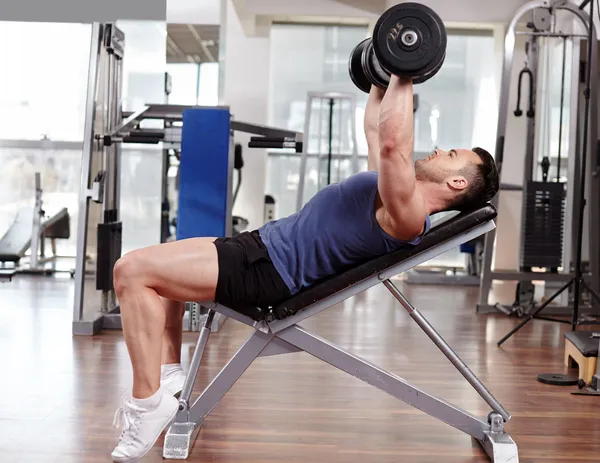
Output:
[111, 391, 179, 463]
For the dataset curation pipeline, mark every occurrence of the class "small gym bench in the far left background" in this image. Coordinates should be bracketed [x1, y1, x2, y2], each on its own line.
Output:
[0, 172, 71, 279]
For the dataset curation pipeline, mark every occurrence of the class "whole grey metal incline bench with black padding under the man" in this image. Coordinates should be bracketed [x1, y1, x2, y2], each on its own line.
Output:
[163, 204, 519, 463]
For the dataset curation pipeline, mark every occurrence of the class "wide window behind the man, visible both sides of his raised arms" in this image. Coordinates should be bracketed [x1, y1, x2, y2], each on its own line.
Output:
[266, 24, 501, 267]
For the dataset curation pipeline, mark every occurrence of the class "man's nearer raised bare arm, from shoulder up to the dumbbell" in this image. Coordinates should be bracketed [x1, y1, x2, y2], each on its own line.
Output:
[378, 76, 427, 240]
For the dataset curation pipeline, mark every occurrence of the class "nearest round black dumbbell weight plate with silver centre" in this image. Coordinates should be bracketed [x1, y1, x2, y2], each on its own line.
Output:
[372, 2, 447, 82]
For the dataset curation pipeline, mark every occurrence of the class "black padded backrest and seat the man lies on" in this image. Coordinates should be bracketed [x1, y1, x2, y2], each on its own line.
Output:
[220, 204, 497, 321]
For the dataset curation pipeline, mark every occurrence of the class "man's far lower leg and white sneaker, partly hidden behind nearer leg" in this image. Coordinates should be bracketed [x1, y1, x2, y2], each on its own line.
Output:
[160, 297, 185, 397]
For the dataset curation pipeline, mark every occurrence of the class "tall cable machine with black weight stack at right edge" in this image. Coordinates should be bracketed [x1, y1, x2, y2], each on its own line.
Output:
[477, 0, 600, 330]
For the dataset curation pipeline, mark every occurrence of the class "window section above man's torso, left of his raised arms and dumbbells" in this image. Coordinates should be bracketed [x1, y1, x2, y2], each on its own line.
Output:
[267, 24, 368, 217]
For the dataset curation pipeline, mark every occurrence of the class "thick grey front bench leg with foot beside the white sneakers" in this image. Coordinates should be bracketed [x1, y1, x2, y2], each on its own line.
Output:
[163, 331, 273, 460]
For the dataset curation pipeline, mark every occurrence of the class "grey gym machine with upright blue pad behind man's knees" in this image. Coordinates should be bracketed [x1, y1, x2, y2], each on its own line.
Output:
[72, 23, 302, 335]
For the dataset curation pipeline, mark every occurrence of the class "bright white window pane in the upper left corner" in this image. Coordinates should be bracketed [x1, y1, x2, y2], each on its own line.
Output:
[0, 22, 91, 141]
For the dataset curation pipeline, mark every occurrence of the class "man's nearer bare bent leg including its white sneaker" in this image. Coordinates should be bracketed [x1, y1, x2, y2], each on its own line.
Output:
[112, 238, 219, 462]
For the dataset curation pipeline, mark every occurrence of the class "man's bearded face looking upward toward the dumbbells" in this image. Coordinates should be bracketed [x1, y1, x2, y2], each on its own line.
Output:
[415, 149, 481, 183]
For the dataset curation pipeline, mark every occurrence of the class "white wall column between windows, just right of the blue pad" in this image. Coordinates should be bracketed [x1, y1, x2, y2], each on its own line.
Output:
[219, 0, 270, 229]
